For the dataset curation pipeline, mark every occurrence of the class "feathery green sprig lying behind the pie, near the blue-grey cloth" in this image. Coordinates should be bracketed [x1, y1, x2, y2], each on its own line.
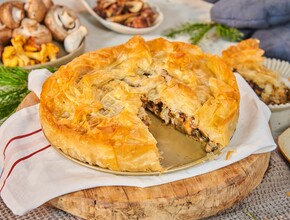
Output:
[163, 22, 243, 44]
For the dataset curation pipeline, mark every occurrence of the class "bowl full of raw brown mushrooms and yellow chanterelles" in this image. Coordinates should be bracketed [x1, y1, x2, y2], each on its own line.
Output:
[0, 0, 87, 69]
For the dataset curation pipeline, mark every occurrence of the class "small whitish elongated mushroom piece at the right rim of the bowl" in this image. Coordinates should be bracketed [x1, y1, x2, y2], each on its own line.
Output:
[64, 26, 88, 53]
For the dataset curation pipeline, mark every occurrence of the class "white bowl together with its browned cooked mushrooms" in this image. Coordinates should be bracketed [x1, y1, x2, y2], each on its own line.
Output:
[82, 0, 163, 34]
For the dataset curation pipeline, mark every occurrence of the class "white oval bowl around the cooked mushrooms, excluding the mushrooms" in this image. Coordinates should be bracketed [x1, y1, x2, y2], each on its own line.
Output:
[82, 0, 163, 35]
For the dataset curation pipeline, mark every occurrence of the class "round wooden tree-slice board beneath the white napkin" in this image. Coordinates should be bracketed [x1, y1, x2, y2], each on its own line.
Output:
[21, 93, 270, 220]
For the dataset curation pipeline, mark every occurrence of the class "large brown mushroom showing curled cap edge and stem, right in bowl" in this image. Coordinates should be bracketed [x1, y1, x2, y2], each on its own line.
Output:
[44, 5, 80, 41]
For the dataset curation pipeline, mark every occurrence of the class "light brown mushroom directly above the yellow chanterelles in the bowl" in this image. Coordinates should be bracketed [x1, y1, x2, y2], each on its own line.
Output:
[12, 18, 52, 45]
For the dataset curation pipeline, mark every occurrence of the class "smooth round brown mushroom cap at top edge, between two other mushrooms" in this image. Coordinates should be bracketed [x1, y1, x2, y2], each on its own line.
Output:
[24, 0, 48, 22]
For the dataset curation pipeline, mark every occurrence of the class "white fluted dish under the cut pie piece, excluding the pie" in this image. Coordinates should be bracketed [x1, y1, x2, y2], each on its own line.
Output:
[264, 58, 290, 137]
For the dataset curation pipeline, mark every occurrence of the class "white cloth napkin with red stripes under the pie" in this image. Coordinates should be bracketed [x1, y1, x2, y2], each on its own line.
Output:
[0, 69, 276, 215]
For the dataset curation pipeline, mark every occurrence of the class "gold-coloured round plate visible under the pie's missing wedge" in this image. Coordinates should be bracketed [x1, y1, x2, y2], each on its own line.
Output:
[53, 112, 220, 176]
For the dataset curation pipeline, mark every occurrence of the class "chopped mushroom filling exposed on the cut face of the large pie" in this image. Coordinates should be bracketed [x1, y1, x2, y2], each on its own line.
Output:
[141, 97, 218, 153]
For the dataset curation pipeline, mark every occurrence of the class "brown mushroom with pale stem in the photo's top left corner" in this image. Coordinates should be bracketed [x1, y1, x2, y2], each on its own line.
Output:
[0, 1, 24, 29]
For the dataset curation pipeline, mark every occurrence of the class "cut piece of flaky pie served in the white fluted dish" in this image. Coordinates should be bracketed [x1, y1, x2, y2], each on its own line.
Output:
[222, 39, 290, 104]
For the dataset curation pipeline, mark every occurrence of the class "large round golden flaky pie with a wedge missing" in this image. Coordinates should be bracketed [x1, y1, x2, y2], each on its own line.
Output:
[40, 36, 240, 171]
